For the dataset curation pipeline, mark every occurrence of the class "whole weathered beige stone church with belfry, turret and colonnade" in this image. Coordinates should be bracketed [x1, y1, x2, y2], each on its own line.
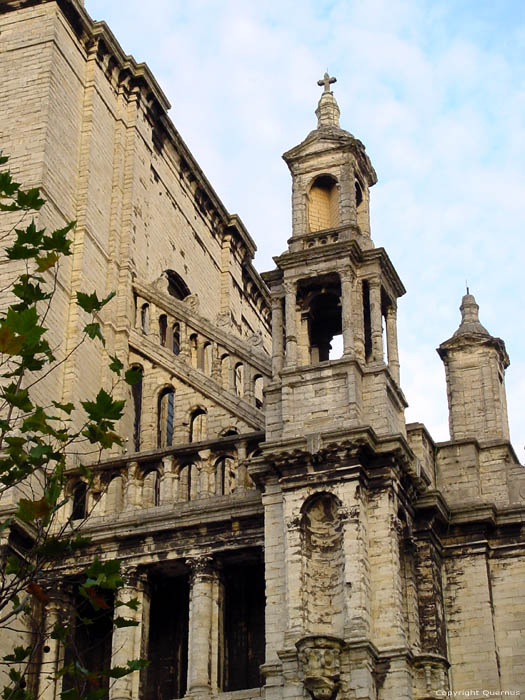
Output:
[0, 0, 525, 700]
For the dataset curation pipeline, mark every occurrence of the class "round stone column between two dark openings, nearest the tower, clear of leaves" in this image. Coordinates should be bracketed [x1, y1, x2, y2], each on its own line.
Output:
[186, 556, 218, 697]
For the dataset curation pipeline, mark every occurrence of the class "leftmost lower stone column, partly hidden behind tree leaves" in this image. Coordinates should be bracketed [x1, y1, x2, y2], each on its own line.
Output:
[38, 581, 74, 700]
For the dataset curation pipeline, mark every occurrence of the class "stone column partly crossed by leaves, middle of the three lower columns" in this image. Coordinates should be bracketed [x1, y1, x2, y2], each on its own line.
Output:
[109, 567, 149, 700]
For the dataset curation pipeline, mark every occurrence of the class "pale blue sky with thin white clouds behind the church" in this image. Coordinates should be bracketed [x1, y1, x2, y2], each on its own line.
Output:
[85, 0, 525, 456]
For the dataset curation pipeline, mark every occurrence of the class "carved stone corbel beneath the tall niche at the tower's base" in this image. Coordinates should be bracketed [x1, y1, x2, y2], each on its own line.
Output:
[296, 635, 344, 700]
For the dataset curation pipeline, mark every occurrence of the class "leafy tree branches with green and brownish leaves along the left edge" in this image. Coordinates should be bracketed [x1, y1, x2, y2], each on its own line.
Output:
[0, 157, 144, 700]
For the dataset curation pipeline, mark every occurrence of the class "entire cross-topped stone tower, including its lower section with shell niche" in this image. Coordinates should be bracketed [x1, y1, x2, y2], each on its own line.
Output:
[249, 74, 440, 700]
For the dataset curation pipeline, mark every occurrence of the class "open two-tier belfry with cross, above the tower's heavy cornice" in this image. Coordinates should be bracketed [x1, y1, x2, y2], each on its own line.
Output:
[264, 74, 405, 441]
